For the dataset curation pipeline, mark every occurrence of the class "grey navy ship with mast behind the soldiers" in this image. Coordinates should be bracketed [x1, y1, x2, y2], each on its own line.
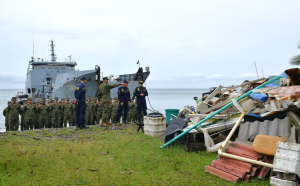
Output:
[19, 40, 150, 104]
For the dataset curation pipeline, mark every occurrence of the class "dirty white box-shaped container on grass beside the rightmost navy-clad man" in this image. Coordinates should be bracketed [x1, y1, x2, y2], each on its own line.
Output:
[144, 116, 167, 137]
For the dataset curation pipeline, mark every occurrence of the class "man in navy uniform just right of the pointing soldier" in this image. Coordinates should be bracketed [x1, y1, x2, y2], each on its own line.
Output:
[115, 80, 130, 124]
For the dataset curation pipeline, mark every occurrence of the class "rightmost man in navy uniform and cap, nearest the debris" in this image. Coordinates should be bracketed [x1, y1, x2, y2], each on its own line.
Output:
[133, 81, 148, 120]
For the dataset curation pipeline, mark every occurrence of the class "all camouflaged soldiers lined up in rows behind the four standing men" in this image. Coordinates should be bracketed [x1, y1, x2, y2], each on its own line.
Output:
[3, 91, 144, 131]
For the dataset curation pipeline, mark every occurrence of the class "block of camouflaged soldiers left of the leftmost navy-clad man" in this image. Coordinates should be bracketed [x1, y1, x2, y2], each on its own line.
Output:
[3, 97, 75, 131]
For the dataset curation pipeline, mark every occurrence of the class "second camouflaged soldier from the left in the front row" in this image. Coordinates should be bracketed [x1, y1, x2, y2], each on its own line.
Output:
[24, 98, 36, 130]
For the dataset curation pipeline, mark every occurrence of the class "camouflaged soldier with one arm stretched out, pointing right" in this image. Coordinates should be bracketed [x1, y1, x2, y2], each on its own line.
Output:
[97, 77, 123, 127]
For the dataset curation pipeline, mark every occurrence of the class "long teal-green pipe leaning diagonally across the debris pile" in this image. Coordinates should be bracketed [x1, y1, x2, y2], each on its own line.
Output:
[160, 76, 281, 148]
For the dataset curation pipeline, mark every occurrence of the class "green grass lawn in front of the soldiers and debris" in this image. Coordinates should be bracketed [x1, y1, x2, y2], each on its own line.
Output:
[0, 126, 269, 186]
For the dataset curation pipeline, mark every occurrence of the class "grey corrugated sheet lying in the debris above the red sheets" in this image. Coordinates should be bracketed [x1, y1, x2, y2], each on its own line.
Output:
[238, 117, 291, 140]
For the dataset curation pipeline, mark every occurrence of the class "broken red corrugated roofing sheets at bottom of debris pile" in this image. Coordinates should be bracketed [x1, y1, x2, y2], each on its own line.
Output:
[205, 142, 269, 183]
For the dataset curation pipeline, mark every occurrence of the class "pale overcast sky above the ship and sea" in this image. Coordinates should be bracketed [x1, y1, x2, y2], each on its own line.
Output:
[0, 0, 300, 89]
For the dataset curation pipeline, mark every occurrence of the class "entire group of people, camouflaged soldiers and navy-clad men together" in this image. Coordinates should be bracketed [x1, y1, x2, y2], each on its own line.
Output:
[3, 76, 148, 131]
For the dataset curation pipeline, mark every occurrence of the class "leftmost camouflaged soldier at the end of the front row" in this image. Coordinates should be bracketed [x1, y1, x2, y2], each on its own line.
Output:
[7, 97, 21, 131]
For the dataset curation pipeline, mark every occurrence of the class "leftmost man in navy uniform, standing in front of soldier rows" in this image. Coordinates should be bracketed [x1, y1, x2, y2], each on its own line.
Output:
[74, 76, 89, 129]
